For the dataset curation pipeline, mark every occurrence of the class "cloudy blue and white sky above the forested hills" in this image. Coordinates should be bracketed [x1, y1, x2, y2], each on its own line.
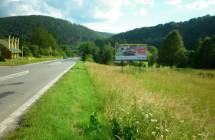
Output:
[0, 0, 215, 33]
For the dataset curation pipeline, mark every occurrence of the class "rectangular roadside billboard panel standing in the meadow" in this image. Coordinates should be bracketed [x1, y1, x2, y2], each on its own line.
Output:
[115, 44, 147, 61]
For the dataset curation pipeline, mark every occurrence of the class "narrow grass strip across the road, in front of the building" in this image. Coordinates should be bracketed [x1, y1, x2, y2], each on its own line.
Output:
[0, 57, 57, 66]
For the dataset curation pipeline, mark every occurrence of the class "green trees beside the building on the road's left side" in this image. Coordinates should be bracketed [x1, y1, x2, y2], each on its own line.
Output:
[21, 25, 72, 57]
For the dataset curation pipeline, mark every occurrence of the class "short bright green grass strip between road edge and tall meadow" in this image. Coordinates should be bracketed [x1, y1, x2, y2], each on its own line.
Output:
[5, 63, 108, 140]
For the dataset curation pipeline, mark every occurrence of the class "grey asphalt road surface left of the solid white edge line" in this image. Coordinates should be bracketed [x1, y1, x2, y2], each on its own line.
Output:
[0, 58, 77, 123]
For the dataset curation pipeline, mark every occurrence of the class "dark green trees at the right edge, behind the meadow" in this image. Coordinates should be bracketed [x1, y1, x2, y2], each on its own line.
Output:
[158, 30, 215, 68]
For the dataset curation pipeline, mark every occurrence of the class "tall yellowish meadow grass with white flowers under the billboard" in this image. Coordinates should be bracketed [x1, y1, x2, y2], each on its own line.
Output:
[87, 63, 215, 139]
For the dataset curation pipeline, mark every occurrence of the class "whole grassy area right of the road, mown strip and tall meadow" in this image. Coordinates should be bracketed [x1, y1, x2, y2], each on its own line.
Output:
[6, 62, 215, 140]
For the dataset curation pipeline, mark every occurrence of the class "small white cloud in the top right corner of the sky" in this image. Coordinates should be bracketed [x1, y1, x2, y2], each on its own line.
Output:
[185, 0, 215, 10]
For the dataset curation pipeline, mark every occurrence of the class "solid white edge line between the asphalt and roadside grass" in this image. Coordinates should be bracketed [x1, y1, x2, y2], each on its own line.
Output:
[0, 62, 76, 138]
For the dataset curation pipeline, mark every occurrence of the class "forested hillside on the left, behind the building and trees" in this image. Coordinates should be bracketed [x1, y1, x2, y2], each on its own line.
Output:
[0, 15, 111, 44]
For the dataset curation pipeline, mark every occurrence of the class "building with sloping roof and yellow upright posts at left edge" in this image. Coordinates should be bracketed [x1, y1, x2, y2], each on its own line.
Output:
[0, 36, 21, 59]
